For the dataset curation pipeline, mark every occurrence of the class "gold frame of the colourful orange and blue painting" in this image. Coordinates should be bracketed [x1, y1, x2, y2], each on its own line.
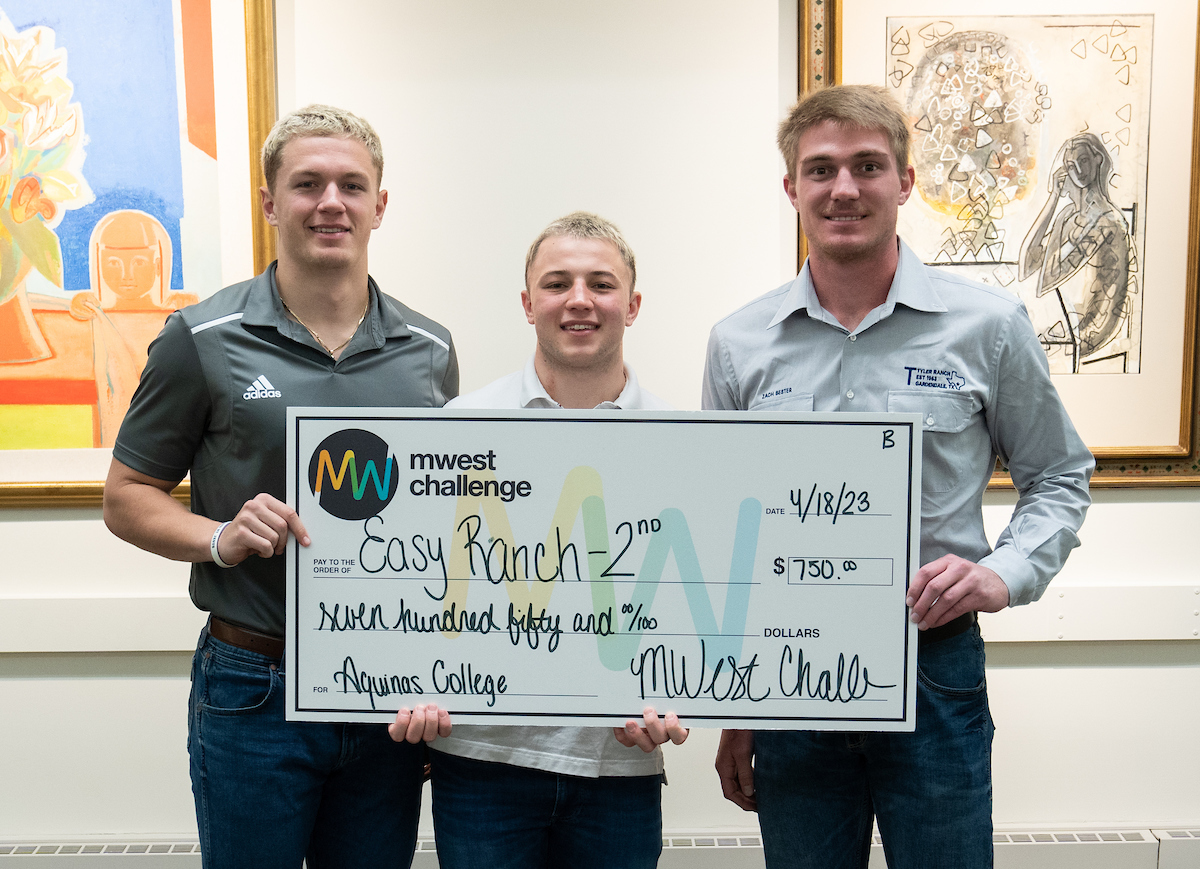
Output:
[0, 0, 276, 509]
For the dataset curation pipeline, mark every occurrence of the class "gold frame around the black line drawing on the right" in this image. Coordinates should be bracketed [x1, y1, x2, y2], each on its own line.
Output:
[798, 0, 1200, 489]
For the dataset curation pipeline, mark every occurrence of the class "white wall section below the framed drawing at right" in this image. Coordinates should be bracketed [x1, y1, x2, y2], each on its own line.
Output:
[984, 489, 1200, 828]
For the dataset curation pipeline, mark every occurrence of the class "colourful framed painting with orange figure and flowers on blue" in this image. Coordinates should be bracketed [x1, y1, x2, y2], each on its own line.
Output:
[0, 0, 275, 507]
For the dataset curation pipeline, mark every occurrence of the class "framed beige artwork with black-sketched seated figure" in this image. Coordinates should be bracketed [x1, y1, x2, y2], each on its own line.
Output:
[799, 0, 1200, 486]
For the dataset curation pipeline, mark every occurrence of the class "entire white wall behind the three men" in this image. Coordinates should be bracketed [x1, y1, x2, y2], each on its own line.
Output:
[0, 0, 1200, 840]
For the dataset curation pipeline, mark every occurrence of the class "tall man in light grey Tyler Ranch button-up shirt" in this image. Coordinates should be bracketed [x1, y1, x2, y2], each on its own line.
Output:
[703, 86, 1093, 869]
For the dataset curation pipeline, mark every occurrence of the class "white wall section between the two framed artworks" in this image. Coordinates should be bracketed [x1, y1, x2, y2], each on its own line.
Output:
[278, 0, 796, 408]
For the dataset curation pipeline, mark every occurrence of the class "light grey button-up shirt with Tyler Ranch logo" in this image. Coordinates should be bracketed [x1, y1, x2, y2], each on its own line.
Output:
[702, 237, 1094, 605]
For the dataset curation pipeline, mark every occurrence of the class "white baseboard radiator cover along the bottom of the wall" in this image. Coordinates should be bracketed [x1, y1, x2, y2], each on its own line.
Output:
[0, 828, 1200, 869]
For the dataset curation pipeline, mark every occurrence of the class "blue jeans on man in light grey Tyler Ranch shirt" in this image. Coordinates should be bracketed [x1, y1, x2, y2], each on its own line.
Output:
[755, 627, 995, 869]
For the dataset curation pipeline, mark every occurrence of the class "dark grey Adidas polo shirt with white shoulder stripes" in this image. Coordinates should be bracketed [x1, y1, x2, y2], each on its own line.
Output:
[113, 265, 458, 636]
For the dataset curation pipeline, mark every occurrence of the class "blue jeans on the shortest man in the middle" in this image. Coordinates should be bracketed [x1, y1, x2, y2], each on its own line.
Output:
[433, 751, 662, 869]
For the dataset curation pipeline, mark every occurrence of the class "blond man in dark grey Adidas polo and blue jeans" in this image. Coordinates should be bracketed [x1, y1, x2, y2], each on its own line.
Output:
[104, 106, 458, 869]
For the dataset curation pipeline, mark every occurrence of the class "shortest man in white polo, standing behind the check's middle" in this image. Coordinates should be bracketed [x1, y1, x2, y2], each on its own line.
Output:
[410, 211, 688, 869]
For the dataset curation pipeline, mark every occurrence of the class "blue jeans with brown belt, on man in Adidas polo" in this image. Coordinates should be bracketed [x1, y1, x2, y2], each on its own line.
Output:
[187, 629, 425, 869]
